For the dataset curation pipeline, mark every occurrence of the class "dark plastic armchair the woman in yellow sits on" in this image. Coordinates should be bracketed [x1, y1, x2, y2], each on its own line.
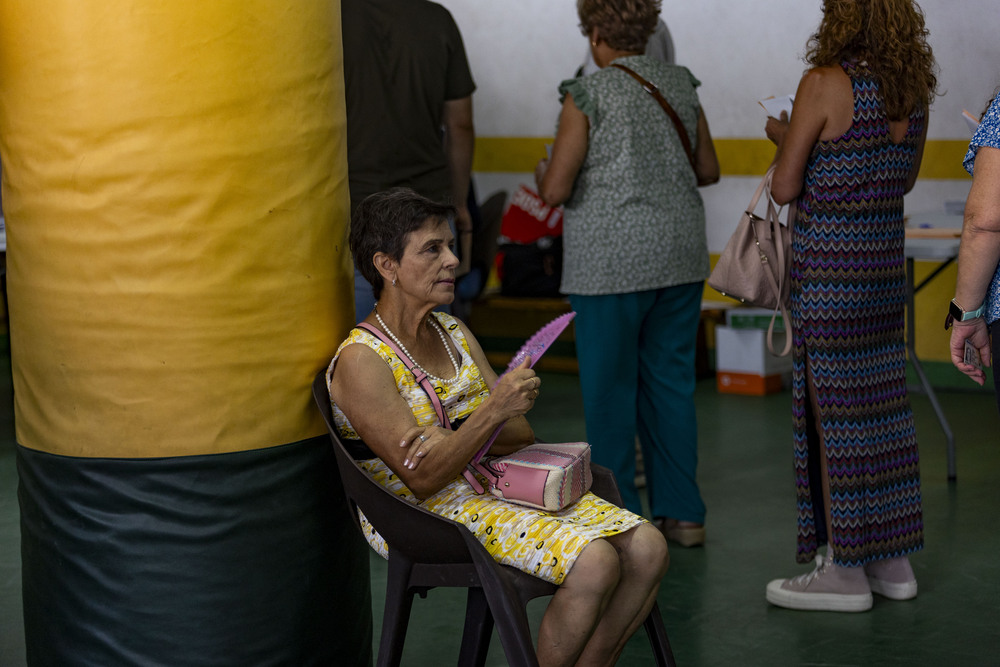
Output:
[313, 371, 676, 667]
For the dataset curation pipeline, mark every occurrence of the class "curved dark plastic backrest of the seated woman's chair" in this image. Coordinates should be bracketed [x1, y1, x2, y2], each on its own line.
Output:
[313, 371, 482, 563]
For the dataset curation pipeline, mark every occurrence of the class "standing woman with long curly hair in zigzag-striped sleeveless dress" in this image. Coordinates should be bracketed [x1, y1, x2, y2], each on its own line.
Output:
[766, 0, 937, 611]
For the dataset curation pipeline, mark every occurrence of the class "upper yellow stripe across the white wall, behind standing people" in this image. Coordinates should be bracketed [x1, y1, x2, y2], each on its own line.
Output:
[472, 137, 969, 180]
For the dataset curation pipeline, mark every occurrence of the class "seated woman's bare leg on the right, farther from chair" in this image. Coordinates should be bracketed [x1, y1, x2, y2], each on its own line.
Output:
[577, 523, 670, 665]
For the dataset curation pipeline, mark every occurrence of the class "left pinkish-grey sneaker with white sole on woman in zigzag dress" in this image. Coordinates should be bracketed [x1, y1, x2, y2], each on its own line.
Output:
[767, 555, 872, 612]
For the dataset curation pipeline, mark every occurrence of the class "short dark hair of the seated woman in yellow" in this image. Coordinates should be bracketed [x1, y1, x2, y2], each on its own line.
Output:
[348, 188, 455, 299]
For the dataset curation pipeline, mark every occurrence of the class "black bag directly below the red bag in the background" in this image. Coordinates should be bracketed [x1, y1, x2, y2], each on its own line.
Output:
[500, 236, 562, 297]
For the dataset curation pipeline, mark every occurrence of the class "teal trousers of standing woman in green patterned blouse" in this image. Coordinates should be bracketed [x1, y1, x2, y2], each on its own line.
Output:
[570, 282, 705, 523]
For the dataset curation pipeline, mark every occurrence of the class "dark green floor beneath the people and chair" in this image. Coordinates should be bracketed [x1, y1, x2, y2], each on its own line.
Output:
[0, 350, 1000, 667]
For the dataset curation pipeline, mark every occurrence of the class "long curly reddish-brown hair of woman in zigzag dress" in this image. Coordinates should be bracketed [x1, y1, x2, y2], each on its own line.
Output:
[805, 0, 937, 120]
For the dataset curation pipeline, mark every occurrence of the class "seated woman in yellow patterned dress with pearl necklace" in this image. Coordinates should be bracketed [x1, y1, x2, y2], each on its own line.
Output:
[330, 189, 668, 665]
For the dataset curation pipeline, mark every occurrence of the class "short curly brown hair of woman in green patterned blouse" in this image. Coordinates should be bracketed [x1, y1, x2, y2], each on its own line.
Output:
[576, 0, 660, 53]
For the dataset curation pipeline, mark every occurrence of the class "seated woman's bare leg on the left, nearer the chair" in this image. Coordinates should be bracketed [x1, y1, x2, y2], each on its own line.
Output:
[538, 540, 620, 667]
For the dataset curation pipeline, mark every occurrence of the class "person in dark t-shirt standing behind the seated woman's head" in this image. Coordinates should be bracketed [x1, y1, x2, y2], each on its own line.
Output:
[341, 0, 476, 321]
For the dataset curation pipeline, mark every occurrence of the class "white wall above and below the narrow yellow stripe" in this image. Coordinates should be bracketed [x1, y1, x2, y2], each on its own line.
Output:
[438, 0, 1000, 252]
